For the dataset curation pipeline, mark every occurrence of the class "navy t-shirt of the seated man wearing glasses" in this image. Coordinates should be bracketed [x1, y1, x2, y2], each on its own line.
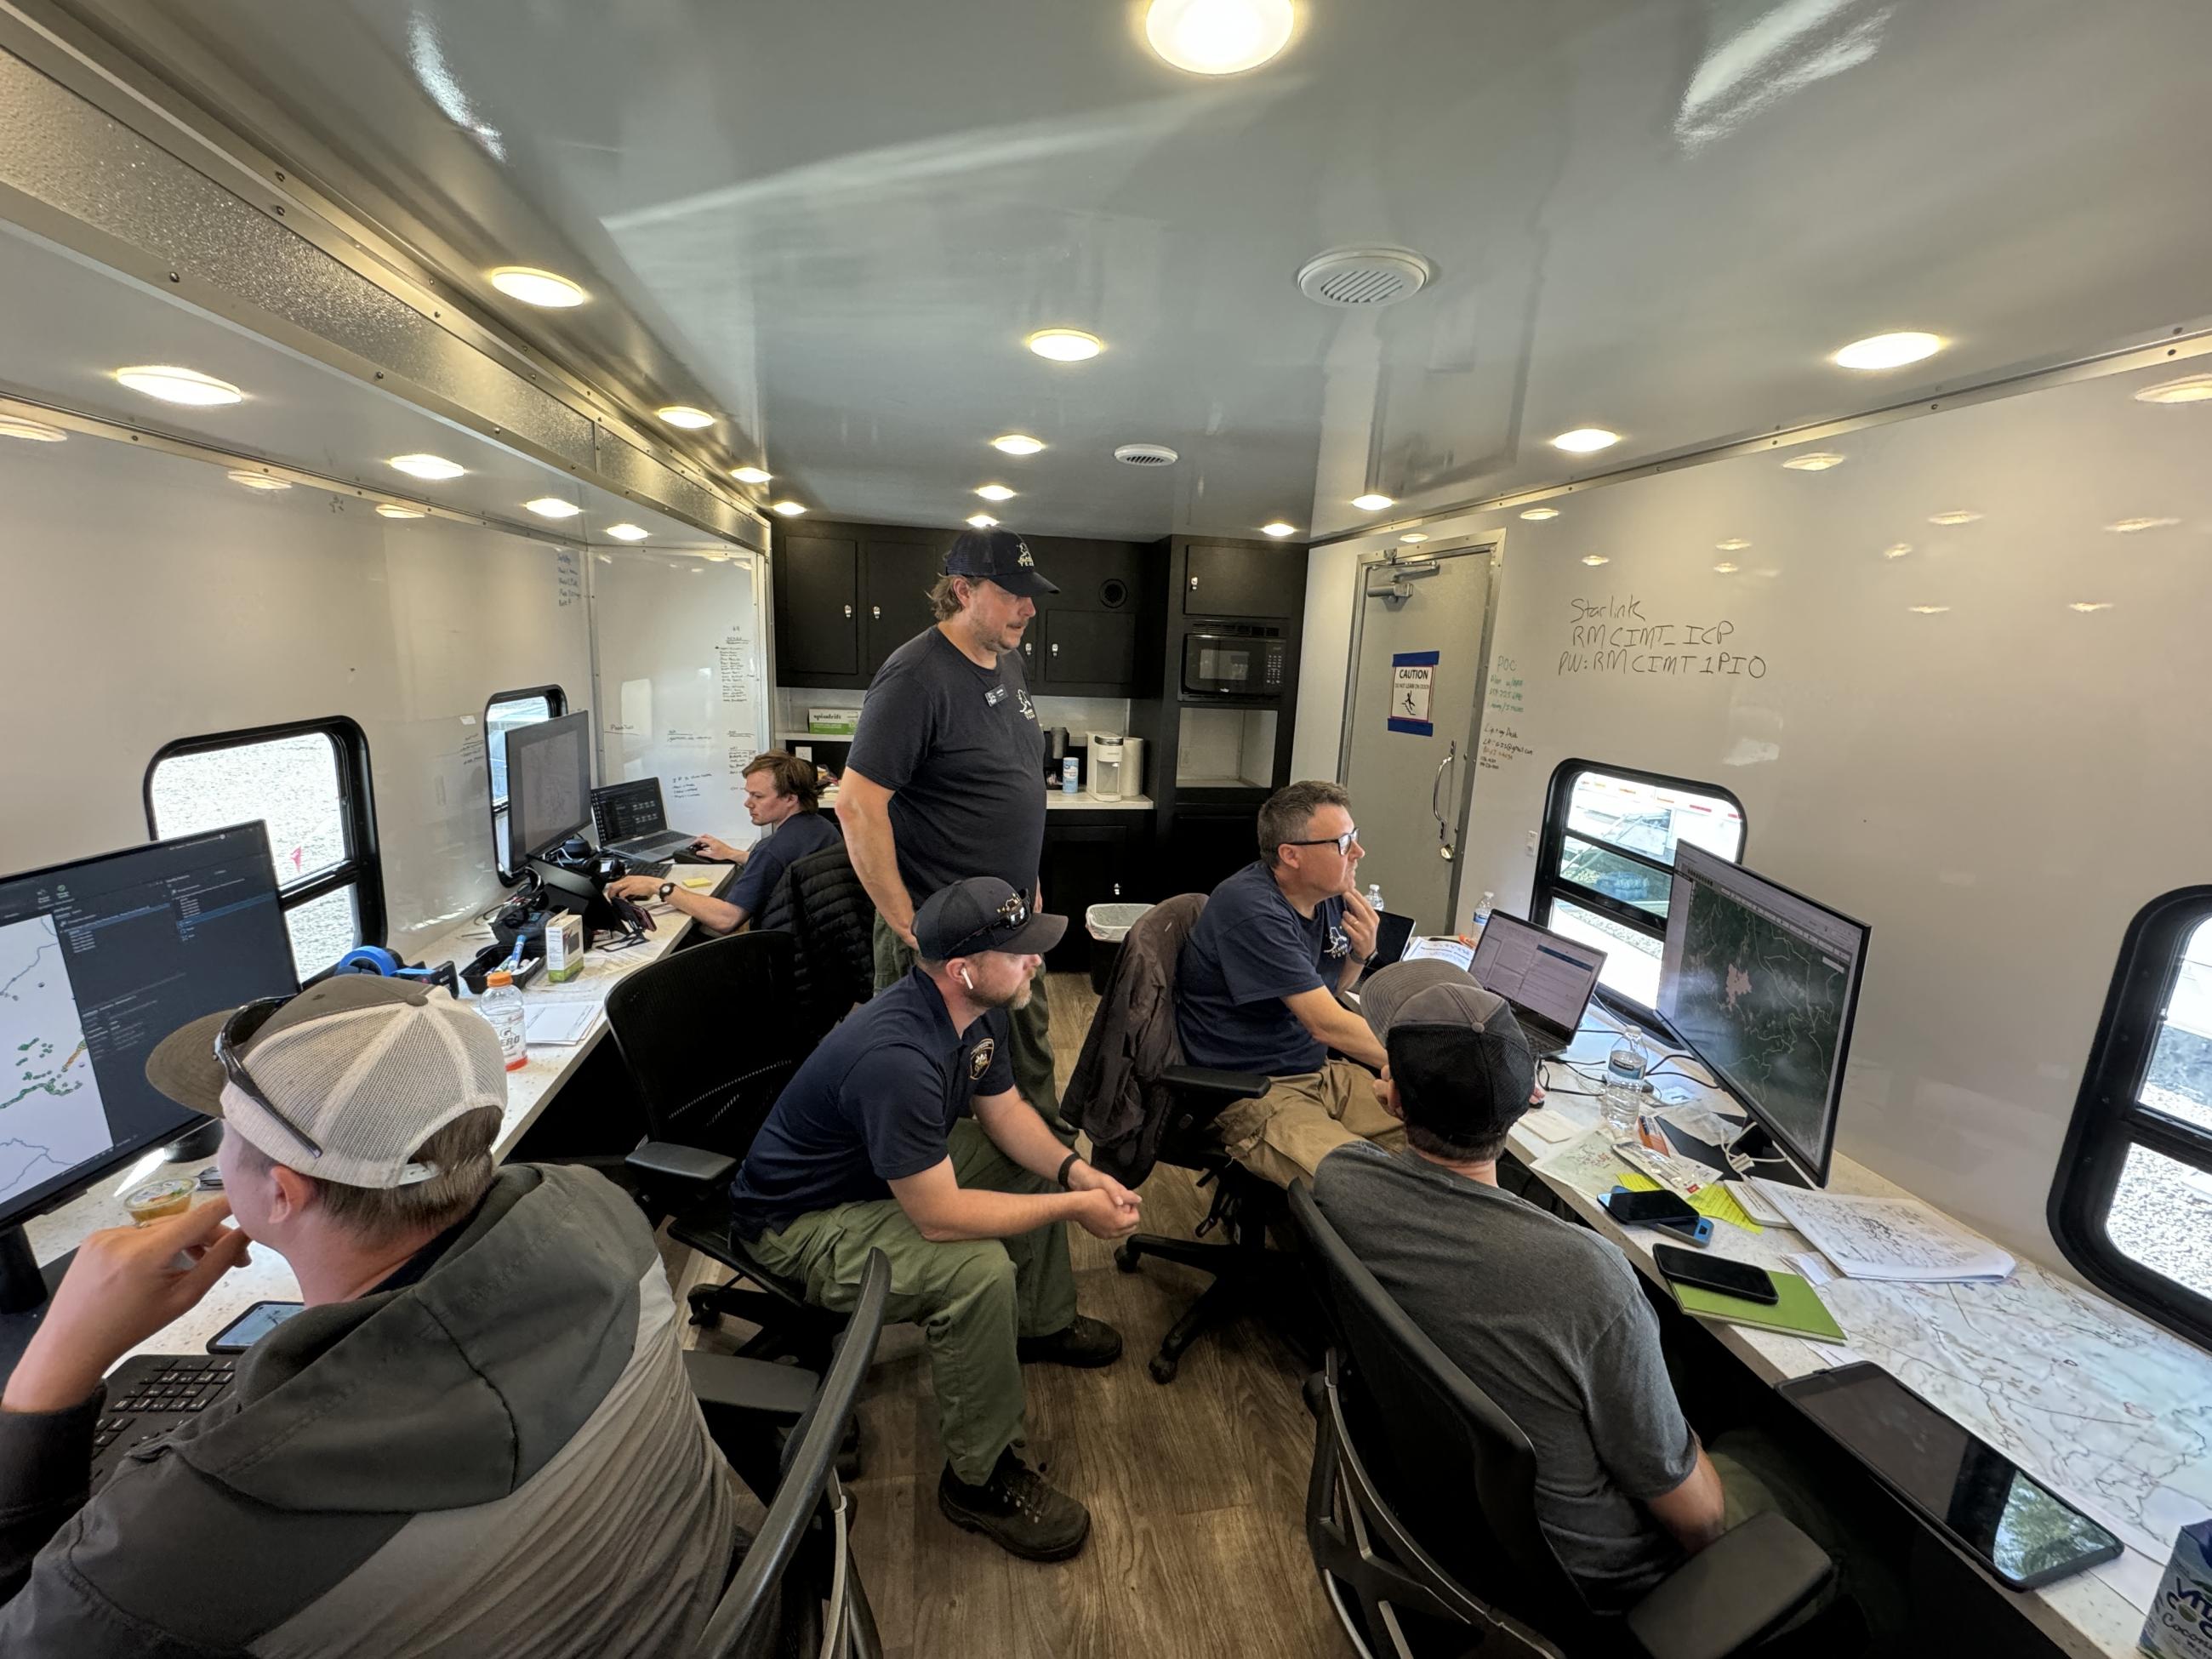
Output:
[1175, 860, 1352, 1077]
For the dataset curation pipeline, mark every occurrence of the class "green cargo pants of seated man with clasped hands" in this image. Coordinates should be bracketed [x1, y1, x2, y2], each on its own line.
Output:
[750, 1120, 1075, 1486]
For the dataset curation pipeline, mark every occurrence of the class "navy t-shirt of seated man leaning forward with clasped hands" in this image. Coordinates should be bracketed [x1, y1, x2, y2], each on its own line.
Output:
[730, 969, 1013, 1239]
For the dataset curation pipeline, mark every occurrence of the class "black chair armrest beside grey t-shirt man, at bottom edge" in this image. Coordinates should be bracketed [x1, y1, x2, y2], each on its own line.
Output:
[1628, 1508, 1836, 1659]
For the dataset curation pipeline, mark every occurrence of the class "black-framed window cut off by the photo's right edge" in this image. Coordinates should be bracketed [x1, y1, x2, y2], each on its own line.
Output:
[2050, 887, 2212, 1347]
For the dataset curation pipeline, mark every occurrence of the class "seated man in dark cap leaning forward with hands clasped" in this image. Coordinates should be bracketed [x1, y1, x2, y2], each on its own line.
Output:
[730, 876, 1139, 1562]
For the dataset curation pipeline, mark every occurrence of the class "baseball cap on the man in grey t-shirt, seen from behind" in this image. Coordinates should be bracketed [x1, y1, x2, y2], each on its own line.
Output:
[1360, 958, 1535, 1146]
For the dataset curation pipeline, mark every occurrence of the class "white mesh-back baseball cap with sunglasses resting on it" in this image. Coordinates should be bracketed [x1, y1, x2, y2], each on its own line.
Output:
[146, 973, 506, 1188]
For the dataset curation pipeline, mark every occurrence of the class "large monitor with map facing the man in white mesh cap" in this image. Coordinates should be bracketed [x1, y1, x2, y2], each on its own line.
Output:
[0, 823, 299, 1250]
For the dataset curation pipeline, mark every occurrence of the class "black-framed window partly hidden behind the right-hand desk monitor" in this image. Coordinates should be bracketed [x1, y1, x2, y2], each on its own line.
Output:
[1529, 761, 1743, 1011]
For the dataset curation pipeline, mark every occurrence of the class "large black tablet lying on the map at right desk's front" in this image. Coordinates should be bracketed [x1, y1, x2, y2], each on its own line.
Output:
[1778, 1360, 2121, 1590]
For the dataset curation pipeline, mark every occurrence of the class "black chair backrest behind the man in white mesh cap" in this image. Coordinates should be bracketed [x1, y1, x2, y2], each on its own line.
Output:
[699, 1250, 892, 1659]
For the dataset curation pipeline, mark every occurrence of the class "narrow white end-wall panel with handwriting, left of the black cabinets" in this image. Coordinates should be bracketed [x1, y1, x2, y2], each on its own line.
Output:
[586, 550, 770, 847]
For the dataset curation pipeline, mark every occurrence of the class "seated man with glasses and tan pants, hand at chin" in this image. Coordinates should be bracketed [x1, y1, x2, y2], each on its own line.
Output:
[1175, 783, 1405, 1188]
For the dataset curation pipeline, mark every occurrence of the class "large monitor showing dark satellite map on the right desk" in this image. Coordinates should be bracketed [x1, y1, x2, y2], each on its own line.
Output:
[1659, 841, 1867, 1186]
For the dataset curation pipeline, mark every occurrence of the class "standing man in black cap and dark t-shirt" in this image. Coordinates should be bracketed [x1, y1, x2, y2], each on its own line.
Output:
[836, 531, 1073, 1142]
